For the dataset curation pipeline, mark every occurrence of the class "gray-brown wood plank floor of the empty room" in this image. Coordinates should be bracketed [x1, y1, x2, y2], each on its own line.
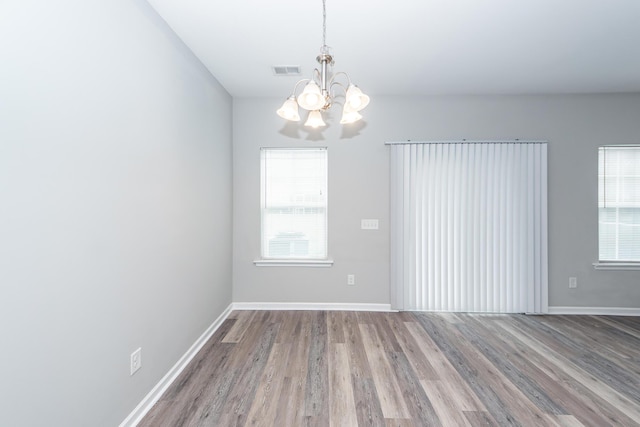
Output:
[139, 311, 640, 427]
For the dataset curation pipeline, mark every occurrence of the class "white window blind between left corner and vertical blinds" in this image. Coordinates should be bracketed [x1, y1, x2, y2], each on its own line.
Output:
[261, 148, 328, 260]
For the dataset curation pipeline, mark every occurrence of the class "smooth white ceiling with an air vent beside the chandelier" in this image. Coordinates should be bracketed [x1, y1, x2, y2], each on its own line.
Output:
[148, 0, 640, 99]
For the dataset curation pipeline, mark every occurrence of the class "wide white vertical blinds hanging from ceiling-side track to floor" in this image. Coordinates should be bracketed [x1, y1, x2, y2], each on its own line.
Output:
[390, 142, 548, 313]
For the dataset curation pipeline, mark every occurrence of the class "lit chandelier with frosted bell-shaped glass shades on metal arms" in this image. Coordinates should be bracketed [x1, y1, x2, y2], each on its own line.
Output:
[277, 0, 369, 128]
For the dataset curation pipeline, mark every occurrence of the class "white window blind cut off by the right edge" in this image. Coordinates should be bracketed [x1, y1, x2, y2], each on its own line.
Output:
[598, 145, 640, 262]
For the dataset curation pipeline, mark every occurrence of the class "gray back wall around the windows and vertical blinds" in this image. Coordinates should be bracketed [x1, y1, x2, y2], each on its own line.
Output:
[233, 95, 640, 308]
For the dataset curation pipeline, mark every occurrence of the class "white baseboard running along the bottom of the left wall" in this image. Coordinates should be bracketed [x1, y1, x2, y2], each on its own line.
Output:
[120, 304, 233, 427]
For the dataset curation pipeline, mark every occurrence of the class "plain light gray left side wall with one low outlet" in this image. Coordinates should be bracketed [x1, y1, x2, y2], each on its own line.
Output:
[0, 0, 232, 427]
